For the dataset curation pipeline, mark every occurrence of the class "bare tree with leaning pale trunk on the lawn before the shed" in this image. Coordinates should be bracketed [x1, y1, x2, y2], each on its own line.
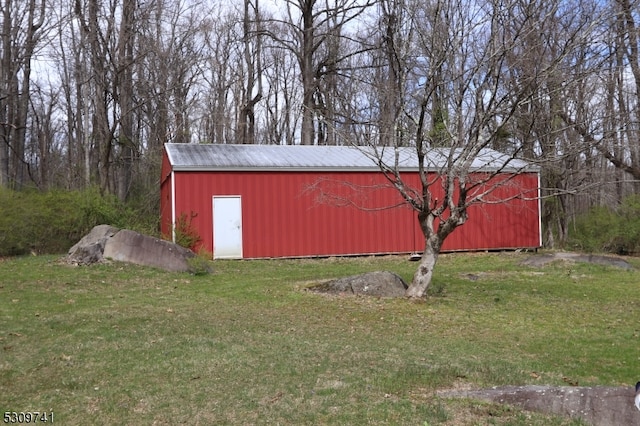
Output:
[348, 0, 592, 297]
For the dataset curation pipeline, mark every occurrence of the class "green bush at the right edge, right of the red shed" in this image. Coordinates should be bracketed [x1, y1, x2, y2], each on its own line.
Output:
[569, 195, 640, 254]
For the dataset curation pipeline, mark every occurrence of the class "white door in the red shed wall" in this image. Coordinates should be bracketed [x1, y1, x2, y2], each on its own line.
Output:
[213, 196, 242, 259]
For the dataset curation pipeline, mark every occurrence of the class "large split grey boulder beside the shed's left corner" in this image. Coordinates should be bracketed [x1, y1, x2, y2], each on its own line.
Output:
[67, 225, 195, 272]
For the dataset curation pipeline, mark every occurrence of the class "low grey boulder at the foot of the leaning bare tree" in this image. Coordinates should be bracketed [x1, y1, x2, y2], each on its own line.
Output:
[311, 271, 408, 297]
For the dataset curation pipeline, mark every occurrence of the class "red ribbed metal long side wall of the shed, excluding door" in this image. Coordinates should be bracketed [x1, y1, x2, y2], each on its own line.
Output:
[169, 171, 540, 258]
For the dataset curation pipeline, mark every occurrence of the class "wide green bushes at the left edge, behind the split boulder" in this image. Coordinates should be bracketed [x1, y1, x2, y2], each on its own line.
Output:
[0, 189, 157, 256]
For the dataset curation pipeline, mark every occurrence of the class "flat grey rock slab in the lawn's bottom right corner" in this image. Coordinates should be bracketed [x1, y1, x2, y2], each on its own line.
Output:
[437, 386, 640, 426]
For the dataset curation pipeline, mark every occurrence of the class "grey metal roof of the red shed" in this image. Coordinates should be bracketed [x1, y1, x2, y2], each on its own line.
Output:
[165, 143, 539, 172]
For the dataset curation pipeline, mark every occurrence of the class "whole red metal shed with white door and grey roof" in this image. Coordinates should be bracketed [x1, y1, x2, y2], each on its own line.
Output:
[160, 144, 541, 258]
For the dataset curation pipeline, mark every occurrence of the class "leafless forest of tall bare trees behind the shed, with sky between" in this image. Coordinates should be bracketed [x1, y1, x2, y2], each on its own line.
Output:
[0, 0, 640, 246]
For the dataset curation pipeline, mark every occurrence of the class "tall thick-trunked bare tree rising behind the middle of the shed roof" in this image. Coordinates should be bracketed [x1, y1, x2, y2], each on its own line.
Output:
[264, 0, 373, 145]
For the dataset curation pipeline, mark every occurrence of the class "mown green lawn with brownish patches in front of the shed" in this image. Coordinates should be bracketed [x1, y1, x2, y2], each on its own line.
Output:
[0, 253, 640, 425]
